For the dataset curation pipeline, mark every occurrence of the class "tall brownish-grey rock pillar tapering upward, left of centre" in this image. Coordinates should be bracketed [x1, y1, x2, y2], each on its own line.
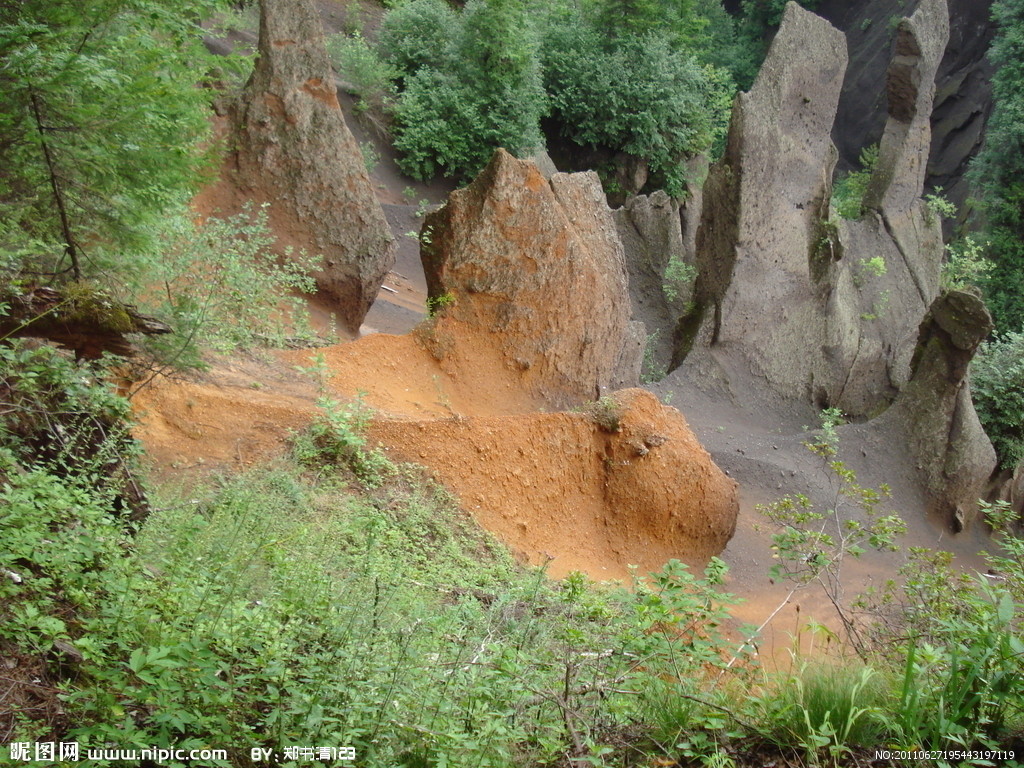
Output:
[234, 0, 394, 333]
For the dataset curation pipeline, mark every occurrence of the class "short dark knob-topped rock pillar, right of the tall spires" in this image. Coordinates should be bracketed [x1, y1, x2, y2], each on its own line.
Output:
[874, 291, 996, 529]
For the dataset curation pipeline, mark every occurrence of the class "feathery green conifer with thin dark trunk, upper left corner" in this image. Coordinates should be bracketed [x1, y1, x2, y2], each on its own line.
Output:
[0, 0, 222, 280]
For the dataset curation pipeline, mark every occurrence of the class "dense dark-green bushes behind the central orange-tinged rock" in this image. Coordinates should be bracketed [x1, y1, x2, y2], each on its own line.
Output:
[354, 0, 743, 195]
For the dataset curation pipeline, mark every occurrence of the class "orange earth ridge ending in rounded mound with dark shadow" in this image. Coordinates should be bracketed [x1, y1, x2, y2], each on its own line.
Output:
[371, 390, 738, 579]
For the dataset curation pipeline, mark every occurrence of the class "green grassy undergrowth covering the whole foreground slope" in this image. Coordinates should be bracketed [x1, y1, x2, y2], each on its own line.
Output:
[0, 349, 1024, 768]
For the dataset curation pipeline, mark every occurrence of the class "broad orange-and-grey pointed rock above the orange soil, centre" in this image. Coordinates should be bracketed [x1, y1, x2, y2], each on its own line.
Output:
[421, 150, 643, 403]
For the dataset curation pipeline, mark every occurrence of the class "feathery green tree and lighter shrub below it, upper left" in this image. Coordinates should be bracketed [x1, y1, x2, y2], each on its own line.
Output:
[0, 0, 319, 367]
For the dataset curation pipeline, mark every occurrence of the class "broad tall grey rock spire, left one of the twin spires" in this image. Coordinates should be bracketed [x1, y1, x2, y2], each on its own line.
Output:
[675, 3, 846, 400]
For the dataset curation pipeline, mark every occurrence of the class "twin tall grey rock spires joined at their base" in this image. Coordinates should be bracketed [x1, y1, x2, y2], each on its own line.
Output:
[676, 0, 948, 418]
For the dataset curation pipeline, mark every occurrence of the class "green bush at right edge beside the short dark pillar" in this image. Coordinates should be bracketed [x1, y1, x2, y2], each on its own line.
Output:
[971, 333, 1024, 469]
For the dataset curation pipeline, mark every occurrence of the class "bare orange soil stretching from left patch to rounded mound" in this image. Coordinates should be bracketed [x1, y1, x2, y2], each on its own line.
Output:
[135, 335, 736, 579]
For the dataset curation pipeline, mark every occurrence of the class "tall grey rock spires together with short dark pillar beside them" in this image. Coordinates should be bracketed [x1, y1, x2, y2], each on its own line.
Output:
[659, 0, 994, 521]
